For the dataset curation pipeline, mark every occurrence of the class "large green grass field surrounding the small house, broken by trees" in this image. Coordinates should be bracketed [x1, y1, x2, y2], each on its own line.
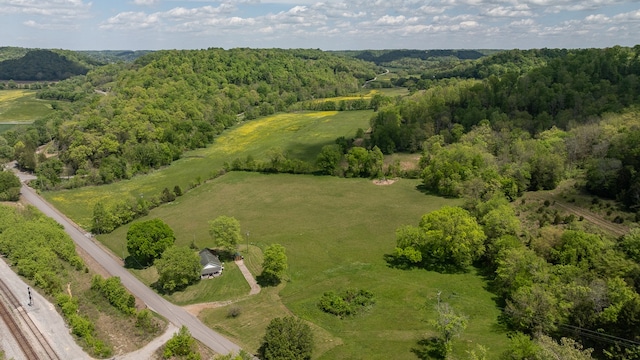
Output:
[99, 172, 507, 359]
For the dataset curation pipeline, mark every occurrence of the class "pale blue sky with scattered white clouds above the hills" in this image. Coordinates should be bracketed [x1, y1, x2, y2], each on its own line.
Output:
[0, 0, 640, 50]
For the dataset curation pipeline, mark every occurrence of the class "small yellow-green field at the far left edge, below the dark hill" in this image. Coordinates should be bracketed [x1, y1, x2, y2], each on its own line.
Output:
[0, 90, 52, 123]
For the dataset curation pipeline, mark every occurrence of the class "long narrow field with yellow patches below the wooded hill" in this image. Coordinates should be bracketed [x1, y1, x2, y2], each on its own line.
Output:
[43, 111, 373, 228]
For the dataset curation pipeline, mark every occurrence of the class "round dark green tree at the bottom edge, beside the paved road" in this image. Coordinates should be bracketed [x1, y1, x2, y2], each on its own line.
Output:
[258, 316, 313, 360]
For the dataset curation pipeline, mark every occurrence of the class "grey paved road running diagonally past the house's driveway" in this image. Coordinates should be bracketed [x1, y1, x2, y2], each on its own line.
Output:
[22, 185, 240, 354]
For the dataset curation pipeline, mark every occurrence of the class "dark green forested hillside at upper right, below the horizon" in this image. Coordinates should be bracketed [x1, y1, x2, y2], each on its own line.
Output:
[372, 47, 640, 149]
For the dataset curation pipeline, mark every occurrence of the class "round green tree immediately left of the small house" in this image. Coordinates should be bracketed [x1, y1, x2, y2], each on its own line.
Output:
[154, 246, 202, 293]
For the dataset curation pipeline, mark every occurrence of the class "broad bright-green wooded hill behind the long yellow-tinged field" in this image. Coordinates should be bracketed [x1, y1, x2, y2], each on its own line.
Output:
[10, 49, 376, 183]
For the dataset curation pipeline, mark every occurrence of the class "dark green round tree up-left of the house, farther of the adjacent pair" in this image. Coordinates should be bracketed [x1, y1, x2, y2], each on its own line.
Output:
[127, 219, 176, 266]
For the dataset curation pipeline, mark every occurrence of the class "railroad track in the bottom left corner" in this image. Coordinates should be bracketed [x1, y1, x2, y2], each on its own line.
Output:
[0, 279, 60, 360]
